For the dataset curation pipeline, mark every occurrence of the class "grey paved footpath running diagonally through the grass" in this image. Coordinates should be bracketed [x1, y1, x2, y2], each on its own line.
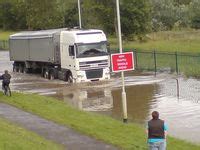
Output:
[0, 103, 117, 150]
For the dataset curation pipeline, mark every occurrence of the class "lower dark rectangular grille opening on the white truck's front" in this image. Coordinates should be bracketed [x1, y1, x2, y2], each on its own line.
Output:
[86, 69, 103, 79]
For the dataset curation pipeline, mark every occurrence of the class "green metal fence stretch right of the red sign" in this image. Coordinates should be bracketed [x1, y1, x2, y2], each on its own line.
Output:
[133, 50, 200, 77]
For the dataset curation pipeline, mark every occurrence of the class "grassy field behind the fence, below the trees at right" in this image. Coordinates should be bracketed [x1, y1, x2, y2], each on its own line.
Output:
[109, 30, 200, 53]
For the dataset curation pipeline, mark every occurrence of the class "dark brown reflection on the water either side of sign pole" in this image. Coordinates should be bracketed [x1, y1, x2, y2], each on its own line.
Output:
[112, 84, 156, 123]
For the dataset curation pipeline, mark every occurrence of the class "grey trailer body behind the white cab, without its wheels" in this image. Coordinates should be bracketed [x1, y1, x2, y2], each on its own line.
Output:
[10, 29, 66, 64]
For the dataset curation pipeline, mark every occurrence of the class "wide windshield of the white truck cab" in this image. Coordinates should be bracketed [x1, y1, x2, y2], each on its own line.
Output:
[76, 42, 108, 58]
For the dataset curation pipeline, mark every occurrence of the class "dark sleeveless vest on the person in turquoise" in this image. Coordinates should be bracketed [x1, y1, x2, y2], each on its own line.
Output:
[148, 119, 165, 139]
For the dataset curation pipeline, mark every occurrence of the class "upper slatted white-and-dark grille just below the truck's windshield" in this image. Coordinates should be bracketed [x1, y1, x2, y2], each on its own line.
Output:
[79, 60, 109, 70]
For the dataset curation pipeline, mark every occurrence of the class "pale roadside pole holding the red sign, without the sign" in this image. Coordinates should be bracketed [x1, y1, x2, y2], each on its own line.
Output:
[116, 0, 128, 123]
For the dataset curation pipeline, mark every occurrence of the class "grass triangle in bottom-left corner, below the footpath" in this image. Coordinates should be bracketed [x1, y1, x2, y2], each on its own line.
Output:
[0, 118, 62, 150]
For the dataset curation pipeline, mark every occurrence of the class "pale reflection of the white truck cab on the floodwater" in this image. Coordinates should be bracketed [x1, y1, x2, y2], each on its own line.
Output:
[58, 85, 113, 111]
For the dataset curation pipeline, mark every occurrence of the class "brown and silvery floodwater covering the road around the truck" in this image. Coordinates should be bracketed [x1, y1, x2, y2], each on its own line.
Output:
[0, 51, 200, 143]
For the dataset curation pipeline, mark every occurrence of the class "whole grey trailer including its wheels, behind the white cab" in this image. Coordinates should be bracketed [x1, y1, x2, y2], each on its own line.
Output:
[9, 28, 67, 78]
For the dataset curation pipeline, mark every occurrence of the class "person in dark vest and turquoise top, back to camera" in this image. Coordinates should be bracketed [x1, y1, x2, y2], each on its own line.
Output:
[147, 111, 167, 150]
